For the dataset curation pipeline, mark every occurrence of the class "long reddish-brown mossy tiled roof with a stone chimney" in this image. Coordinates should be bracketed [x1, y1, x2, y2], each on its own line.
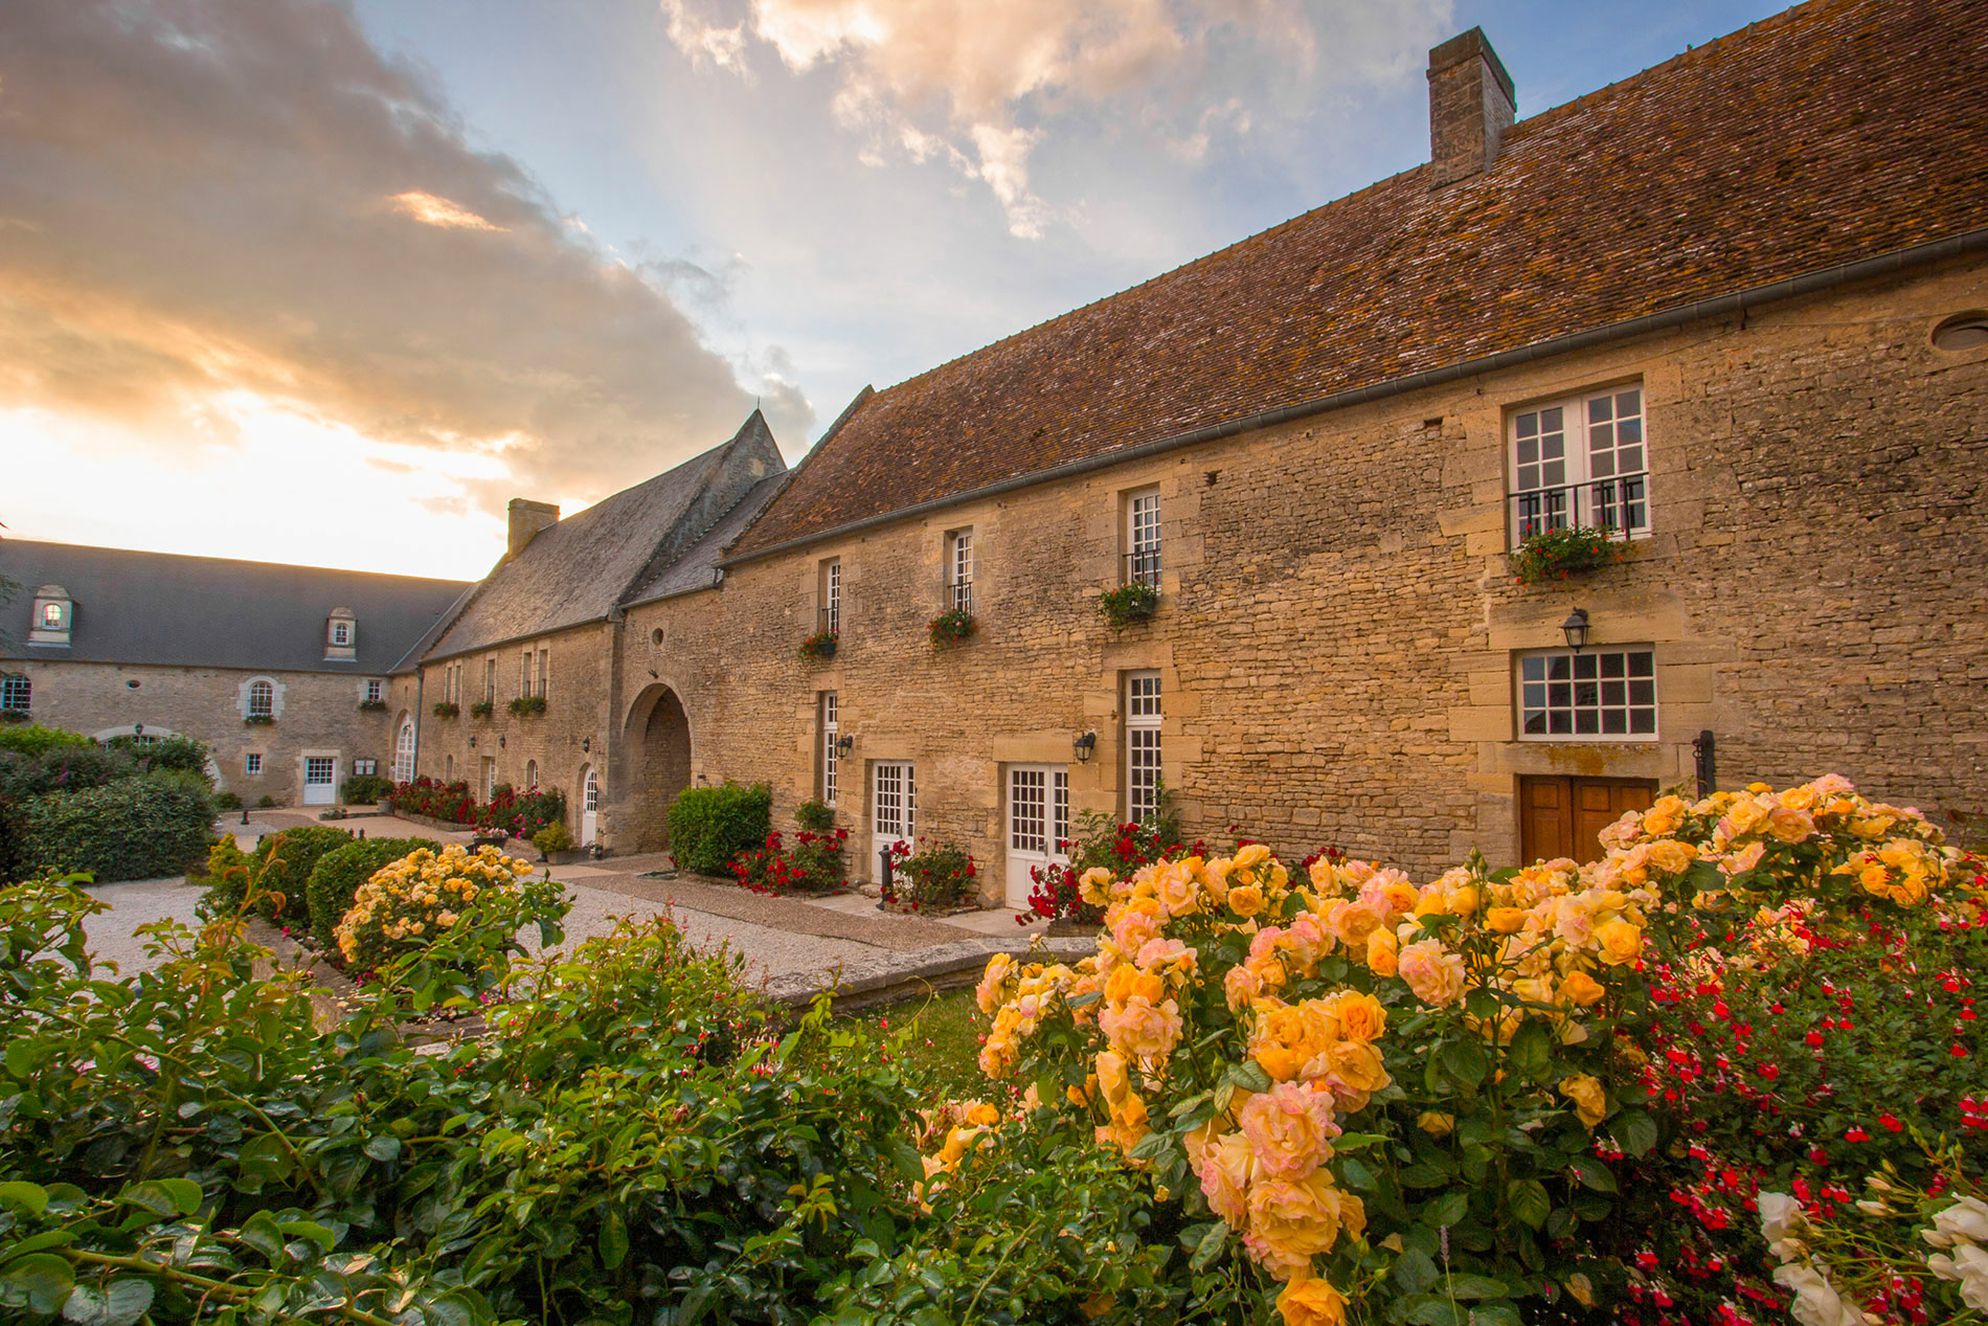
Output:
[732, 0, 1988, 557]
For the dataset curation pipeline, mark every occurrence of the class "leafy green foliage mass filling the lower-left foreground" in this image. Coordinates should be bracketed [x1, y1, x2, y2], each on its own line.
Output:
[0, 885, 918, 1326]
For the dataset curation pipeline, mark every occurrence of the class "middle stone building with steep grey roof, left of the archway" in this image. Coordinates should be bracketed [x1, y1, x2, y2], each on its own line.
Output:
[390, 410, 787, 851]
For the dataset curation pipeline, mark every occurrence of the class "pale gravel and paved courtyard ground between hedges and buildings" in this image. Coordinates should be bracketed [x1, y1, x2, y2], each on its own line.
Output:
[89, 811, 1042, 990]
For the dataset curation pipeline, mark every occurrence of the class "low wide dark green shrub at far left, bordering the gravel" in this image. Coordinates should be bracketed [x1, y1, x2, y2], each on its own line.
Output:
[24, 777, 215, 883]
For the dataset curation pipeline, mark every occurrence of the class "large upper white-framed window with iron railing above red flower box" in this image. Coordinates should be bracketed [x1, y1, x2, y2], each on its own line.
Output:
[1509, 384, 1650, 547]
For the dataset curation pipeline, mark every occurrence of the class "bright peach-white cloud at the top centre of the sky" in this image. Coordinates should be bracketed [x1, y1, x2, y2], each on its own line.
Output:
[658, 0, 1451, 239]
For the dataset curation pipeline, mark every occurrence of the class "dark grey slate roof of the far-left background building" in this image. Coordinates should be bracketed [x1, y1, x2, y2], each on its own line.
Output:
[0, 539, 469, 676]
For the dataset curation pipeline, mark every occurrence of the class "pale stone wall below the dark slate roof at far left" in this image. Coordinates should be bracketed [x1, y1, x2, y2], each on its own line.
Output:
[8, 658, 394, 805]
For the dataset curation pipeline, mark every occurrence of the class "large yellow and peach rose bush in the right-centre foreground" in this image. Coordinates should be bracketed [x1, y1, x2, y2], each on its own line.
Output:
[940, 843, 1658, 1326]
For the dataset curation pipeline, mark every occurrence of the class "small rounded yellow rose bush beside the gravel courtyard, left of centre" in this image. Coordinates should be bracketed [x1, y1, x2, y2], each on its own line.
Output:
[334, 845, 565, 990]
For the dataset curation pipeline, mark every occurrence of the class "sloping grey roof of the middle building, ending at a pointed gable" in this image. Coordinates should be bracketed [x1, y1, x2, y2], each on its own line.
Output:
[427, 410, 787, 660]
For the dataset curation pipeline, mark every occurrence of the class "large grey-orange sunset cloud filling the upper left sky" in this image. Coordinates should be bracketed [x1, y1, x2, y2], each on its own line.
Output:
[0, 0, 813, 503]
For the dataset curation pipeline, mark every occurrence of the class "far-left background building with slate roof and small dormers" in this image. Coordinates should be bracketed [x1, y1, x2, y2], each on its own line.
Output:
[0, 539, 469, 805]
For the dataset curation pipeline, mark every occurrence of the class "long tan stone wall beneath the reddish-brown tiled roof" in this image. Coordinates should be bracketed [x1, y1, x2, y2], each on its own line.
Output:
[610, 264, 1988, 895]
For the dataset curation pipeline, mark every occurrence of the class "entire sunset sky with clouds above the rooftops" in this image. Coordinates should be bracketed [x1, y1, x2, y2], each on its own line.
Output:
[0, 0, 1783, 579]
